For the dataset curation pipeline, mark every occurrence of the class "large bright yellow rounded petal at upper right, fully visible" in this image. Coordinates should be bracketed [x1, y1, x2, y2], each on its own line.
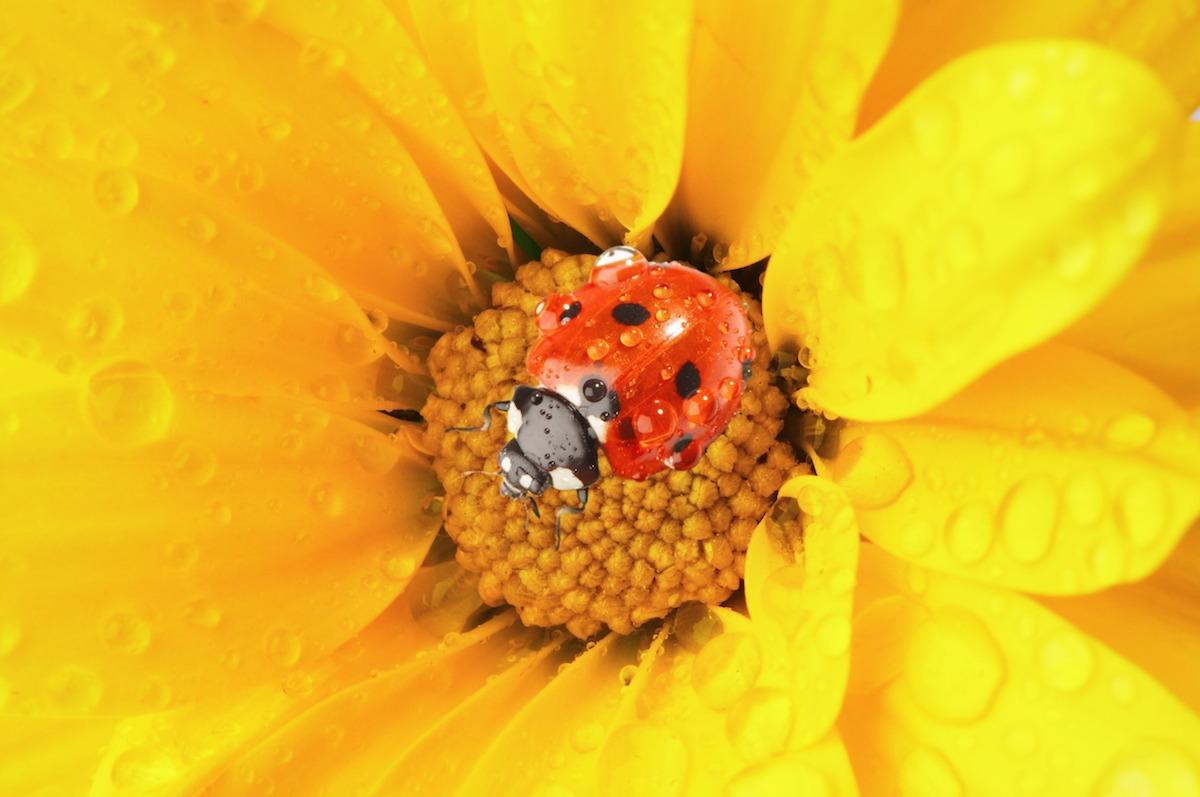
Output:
[763, 42, 1178, 420]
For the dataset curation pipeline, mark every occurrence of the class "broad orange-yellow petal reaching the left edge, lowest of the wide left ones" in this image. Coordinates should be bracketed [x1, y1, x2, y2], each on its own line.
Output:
[0, 358, 440, 715]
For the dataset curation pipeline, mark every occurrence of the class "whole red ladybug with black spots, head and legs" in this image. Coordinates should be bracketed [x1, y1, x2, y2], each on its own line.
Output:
[452, 246, 755, 547]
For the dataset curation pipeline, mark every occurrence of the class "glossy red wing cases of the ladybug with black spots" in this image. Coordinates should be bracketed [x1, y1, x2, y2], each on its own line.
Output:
[526, 257, 754, 479]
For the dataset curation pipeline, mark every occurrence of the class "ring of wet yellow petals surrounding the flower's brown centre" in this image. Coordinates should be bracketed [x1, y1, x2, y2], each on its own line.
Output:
[0, 0, 1200, 796]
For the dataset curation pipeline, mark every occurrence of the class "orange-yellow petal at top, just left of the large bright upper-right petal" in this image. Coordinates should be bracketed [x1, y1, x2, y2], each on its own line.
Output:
[658, 0, 899, 269]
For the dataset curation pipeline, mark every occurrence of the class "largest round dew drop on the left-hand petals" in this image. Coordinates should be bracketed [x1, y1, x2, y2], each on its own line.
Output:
[84, 361, 175, 447]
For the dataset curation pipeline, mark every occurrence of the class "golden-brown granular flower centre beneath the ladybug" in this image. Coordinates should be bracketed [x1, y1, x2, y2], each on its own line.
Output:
[421, 250, 798, 637]
